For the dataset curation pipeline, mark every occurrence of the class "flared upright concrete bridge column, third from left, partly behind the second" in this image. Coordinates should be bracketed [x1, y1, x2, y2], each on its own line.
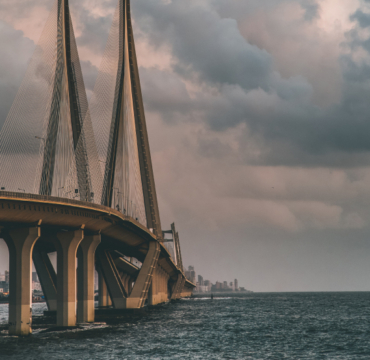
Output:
[77, 235, 101, 323]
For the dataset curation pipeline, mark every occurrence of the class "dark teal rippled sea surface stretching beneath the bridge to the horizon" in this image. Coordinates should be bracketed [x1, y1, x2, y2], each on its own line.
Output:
[0, 292, 370, 360]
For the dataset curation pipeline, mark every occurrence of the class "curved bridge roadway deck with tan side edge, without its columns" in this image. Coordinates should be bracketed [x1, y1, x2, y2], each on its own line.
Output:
[0, 191, 181, 275]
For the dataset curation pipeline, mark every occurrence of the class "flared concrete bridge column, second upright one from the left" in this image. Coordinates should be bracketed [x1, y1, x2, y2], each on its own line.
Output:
[55, 230, 84, 326]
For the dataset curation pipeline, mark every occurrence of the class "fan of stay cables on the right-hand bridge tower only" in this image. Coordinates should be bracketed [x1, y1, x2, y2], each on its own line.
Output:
[90, 1, 147, 226]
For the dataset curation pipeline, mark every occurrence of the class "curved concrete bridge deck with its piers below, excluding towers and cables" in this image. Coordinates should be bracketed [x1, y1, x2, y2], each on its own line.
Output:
[0, 192, 195, 335]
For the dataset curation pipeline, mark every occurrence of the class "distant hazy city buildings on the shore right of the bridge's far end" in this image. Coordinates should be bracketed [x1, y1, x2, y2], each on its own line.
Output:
[185, 266, 250, 293]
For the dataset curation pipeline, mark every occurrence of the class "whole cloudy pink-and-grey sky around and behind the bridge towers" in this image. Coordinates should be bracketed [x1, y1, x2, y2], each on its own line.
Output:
[0, 0, 370, 291]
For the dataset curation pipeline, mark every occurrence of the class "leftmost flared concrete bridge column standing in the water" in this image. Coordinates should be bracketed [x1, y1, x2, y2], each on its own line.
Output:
[2, 227, 40, 335]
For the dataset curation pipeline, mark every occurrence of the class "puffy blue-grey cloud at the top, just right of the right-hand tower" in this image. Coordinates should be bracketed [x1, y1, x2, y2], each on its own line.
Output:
[133, 0, 271, 89]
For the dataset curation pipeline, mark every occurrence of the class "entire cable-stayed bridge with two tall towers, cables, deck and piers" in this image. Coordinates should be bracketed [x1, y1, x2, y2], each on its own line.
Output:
[0, 0, 195, 335]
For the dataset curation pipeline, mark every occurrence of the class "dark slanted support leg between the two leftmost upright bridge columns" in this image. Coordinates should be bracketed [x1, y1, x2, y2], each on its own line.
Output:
[32, 244, 57, 311]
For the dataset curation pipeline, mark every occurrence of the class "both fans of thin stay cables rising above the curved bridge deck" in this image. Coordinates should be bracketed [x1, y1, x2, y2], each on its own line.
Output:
[0, 0, 147, 226]
